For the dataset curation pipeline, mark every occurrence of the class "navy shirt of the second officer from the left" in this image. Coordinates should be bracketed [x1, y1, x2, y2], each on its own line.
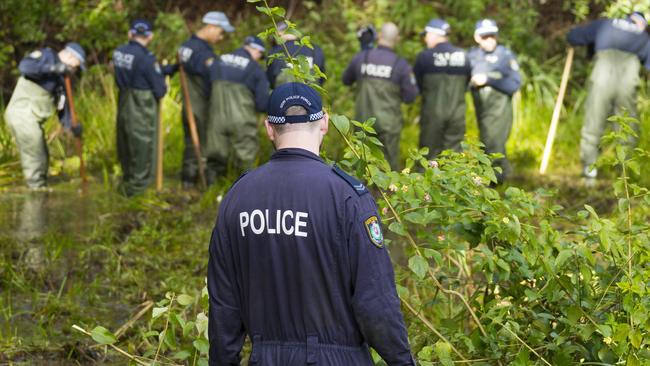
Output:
[113, 41, 167, 99]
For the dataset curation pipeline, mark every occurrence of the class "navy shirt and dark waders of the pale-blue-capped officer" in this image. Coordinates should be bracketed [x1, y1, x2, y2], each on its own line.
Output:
[178, 35, 219, 184]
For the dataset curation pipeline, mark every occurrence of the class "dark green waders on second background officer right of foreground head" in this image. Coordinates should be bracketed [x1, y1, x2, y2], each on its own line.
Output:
[420, 74, 467, 157]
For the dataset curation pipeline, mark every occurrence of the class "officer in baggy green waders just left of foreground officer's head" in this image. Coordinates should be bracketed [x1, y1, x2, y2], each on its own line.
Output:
[207, 36, 269, 176]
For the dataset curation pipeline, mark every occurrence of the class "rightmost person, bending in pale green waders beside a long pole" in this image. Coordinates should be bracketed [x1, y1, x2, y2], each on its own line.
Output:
[567, 12, 650, 179]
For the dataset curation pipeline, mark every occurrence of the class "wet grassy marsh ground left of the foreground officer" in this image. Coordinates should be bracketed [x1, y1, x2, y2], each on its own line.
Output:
[0, 185, 214, 365]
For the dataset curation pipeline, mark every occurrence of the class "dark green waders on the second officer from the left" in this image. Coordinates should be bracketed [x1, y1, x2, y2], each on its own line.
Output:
[116, 89, 158, 196]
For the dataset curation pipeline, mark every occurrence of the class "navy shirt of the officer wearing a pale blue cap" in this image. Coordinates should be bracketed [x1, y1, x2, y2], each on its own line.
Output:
[178, 34, 219, 95]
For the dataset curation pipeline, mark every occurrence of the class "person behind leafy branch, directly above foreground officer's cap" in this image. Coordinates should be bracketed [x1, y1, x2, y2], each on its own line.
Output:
[266, 22, 325, 88]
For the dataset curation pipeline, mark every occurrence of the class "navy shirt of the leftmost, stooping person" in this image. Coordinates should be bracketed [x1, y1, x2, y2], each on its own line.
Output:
[18, 47, 72, 128]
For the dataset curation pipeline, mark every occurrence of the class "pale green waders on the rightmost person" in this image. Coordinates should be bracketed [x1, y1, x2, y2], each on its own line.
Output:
[580, 50, 641, 166]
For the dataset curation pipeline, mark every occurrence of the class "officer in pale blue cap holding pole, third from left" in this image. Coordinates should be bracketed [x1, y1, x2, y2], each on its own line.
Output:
[178, 11, 235, 188]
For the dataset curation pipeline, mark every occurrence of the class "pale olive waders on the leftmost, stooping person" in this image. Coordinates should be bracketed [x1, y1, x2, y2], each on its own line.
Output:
[5, 76, 54, 188]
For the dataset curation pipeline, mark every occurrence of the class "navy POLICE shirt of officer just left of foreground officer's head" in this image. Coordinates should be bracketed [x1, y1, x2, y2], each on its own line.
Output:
[211, 47, 269, 112]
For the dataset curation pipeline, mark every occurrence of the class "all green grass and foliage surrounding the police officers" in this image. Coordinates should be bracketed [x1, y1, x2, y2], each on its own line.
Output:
[0, 0, 650, 365]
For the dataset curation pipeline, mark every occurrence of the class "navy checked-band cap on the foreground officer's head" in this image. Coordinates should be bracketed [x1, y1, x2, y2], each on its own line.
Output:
[268, 83, 325, 125]
